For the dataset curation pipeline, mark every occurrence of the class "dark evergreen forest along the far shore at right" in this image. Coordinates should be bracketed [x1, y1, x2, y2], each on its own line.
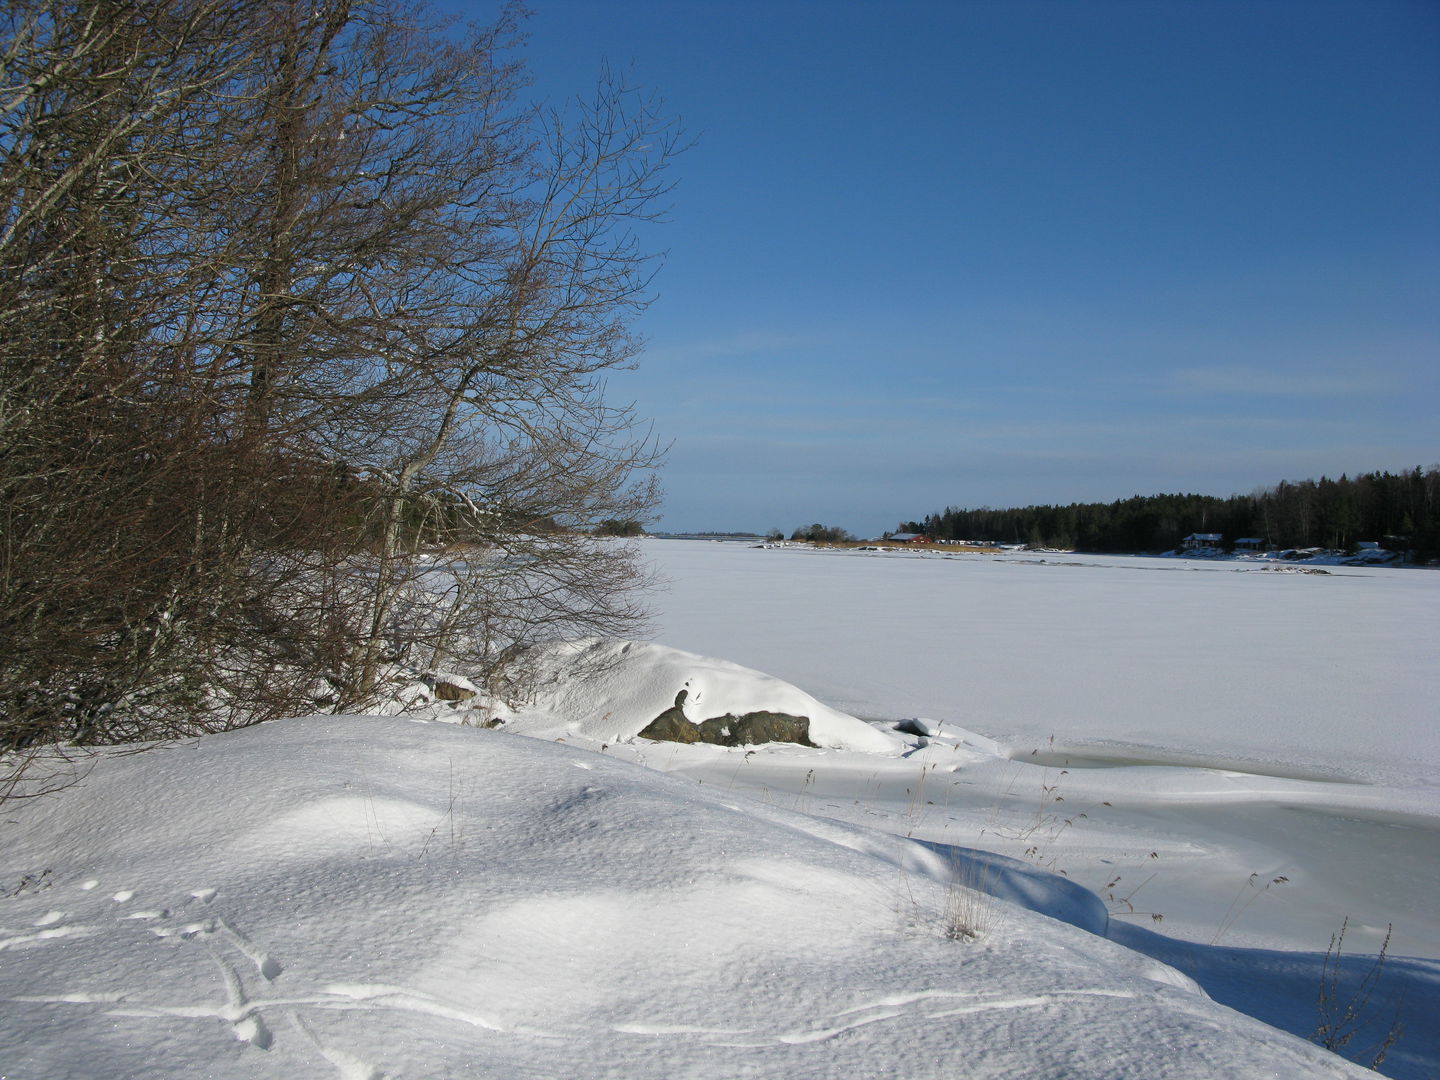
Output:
[899, 467, 1440, 560]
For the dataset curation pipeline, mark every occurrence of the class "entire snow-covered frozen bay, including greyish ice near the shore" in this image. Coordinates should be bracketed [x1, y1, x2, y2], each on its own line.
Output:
[633, 541, 1440, 961]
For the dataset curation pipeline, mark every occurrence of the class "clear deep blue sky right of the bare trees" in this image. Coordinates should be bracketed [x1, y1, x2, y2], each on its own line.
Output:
[446, 0, 1440, 536]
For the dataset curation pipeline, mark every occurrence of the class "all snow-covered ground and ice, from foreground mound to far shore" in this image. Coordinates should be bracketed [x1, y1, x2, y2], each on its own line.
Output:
[0, 541, 1440, 1080]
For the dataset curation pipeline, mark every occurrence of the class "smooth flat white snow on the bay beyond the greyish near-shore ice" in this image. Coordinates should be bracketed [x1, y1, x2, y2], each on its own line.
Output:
[644, 540, 1440, 788]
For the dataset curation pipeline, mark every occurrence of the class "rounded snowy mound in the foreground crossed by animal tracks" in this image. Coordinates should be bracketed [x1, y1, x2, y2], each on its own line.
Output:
[0, 717, 1362, 1080]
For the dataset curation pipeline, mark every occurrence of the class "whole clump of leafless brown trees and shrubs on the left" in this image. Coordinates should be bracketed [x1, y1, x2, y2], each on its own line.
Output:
[0, 0, 674, 760]
